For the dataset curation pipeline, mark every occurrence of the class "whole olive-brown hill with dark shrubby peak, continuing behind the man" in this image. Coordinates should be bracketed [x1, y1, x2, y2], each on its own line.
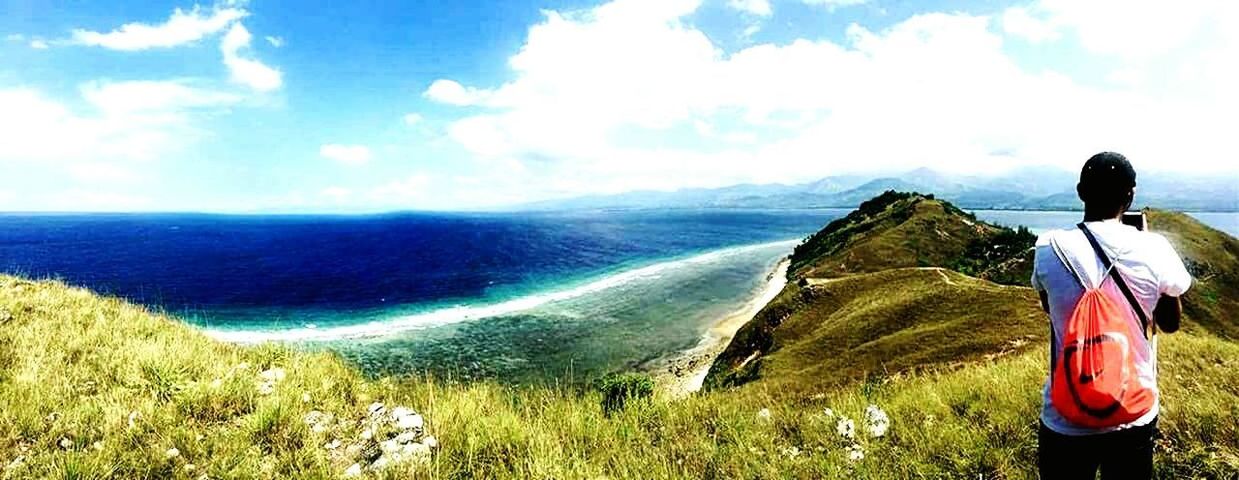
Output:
[705, 198, 1239, 389]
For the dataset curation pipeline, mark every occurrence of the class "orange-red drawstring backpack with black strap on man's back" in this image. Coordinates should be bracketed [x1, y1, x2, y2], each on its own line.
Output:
[1049, 223, 1156, 428]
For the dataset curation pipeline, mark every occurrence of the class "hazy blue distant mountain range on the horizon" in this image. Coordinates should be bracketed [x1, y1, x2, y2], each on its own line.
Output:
[515, 167, 1239, 212]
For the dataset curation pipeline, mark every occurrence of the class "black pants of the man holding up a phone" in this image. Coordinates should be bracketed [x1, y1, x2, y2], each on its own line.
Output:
[1037, 419, 1157, 480]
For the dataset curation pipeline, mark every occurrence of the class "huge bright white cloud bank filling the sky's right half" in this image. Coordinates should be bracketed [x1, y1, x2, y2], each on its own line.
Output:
[425, 0, 1239, 196]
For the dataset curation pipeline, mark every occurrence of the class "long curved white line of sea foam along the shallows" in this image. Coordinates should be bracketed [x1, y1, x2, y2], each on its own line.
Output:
[203, 241, 798, 344]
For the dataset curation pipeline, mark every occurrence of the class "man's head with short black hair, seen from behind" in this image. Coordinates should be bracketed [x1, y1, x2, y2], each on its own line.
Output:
[1075, 151, 1136, 216]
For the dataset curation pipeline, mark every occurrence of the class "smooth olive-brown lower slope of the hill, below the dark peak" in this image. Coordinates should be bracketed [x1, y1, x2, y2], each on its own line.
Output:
[706, 268, 1047, 389]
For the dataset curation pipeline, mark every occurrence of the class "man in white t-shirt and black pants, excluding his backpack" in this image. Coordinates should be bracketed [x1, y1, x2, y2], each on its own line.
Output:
[1032, 153, 1192, 479]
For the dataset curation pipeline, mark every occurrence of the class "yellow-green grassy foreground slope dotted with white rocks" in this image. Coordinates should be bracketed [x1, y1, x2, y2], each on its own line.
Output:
[0, 273, 1239, 479]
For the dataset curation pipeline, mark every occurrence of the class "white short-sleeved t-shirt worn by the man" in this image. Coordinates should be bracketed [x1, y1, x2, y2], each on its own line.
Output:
[1032, 220, 1192, 435]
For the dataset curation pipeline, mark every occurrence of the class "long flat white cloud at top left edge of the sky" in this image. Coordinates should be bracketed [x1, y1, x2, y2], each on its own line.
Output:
[73, 6, 247, 51]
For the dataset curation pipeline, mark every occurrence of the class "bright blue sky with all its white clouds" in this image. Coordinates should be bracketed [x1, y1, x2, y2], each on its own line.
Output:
[0, 0, 1239, 212]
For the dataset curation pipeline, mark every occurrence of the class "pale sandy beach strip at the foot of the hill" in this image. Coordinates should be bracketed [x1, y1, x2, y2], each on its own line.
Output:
[646, 257, 792, 399]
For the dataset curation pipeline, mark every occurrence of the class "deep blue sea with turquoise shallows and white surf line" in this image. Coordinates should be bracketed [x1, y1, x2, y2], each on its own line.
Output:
[0, 208, 1239, 381]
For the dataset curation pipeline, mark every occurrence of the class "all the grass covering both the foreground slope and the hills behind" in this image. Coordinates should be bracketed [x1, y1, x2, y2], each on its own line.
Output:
[0, 201, 1239, 479]
